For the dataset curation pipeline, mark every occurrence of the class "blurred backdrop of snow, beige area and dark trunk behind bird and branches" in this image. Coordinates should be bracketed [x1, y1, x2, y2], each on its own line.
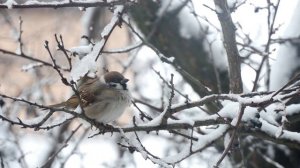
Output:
[0, 0, 300, 168]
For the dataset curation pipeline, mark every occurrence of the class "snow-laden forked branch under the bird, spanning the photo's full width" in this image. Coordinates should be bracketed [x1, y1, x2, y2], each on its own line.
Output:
[0, 75, 300, 167]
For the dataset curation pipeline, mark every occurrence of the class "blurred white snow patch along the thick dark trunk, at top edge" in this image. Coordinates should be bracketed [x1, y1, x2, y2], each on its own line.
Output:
[178, 1, 228, 70]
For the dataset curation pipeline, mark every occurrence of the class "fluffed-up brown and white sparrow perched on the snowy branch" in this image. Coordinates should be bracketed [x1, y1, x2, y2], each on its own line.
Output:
[50, 71, 131, 124]
